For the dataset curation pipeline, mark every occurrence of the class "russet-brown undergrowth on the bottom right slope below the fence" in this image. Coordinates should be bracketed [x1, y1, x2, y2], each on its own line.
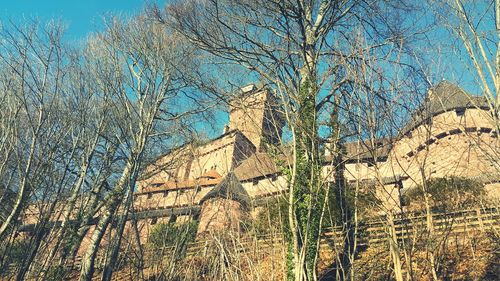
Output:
[354, 232, 500, 281]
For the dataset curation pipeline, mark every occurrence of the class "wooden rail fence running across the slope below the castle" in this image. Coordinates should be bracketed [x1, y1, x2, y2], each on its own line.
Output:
[139, 207, 500, 256]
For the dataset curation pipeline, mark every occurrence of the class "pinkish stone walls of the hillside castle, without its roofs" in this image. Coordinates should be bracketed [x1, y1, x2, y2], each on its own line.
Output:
[16, 83, 500, 260]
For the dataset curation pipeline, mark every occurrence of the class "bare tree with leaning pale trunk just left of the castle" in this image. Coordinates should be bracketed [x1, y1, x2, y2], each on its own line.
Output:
[80, 17, 204, 280]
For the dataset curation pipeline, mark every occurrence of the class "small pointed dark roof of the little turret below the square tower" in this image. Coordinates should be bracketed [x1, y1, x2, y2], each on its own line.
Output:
[200, 172, 251, 207]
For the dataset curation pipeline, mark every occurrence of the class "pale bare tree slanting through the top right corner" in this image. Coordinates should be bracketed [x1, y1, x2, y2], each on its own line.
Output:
[429, 0, 500, 131]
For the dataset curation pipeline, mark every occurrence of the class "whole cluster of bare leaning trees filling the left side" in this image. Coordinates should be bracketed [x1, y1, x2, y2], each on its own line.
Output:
[0, 16, 208, 280]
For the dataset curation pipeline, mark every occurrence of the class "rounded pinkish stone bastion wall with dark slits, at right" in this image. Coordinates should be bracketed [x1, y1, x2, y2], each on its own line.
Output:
[382, 109, 500, 188]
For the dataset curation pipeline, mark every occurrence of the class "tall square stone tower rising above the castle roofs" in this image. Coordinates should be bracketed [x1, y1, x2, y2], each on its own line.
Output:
[229, 84, 283, 151]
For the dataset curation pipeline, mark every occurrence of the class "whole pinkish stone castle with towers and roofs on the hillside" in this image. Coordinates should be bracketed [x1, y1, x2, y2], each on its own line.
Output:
[134, 81, 500, 237]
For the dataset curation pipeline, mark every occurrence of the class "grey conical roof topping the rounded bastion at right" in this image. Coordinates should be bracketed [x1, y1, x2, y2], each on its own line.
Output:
[400, 81, 489, 136]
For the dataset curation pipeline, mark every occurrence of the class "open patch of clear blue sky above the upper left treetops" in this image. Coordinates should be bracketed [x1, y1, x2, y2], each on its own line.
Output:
[0, 0, 165, 40]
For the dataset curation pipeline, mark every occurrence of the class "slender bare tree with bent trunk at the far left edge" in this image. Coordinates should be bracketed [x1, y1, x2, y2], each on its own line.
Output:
[0, 20, 68, 237]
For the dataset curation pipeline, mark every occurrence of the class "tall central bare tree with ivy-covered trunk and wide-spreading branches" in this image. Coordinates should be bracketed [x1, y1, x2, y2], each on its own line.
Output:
[152, 0, 426, 280]
